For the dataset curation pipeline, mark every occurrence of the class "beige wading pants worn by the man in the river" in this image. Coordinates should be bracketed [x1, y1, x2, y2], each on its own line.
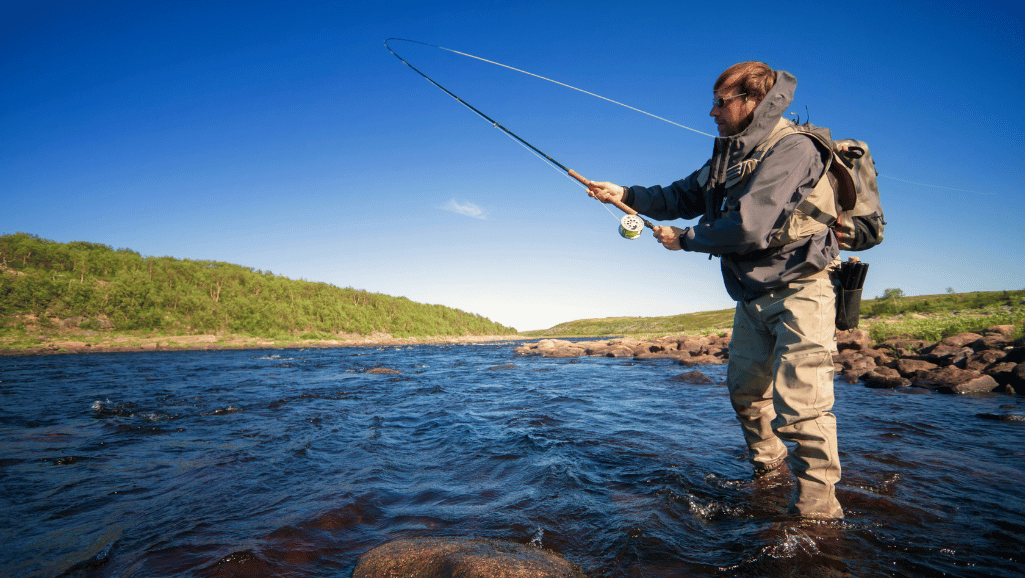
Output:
[727, 267, 844, 519]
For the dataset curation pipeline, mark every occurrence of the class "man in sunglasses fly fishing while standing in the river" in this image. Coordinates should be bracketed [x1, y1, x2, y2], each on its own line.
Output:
[588, 63, 844, 519]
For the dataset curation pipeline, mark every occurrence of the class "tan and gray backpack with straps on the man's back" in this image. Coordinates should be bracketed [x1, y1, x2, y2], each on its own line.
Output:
[742, 119, 886, 251]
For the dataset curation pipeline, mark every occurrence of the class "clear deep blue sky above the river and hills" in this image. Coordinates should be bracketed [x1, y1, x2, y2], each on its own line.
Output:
[0, 0, 1025, 331]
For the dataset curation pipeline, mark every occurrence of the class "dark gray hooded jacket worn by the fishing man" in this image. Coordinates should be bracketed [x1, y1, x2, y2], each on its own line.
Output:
[625, 71, 839, 301]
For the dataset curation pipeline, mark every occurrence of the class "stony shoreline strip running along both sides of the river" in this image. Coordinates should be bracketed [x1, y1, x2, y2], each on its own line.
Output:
[0, 325, 1025, 395]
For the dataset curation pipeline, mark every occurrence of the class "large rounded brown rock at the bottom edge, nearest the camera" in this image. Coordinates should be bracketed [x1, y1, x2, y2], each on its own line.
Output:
[353, 538, 583, 578]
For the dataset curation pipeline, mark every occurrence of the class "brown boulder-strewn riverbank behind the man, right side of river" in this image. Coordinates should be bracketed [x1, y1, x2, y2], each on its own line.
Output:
[516, 325, 1025, 395]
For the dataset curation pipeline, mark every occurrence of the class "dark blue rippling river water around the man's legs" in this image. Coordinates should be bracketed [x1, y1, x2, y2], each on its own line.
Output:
[0, 343, 1025, 577]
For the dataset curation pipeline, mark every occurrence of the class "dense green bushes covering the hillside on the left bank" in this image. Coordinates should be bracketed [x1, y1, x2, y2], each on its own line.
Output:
[0, 233, 517, 338]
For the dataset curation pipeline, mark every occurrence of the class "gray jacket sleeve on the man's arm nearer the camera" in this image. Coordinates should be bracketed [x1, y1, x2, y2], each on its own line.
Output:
[681, 135, 827, 255]
